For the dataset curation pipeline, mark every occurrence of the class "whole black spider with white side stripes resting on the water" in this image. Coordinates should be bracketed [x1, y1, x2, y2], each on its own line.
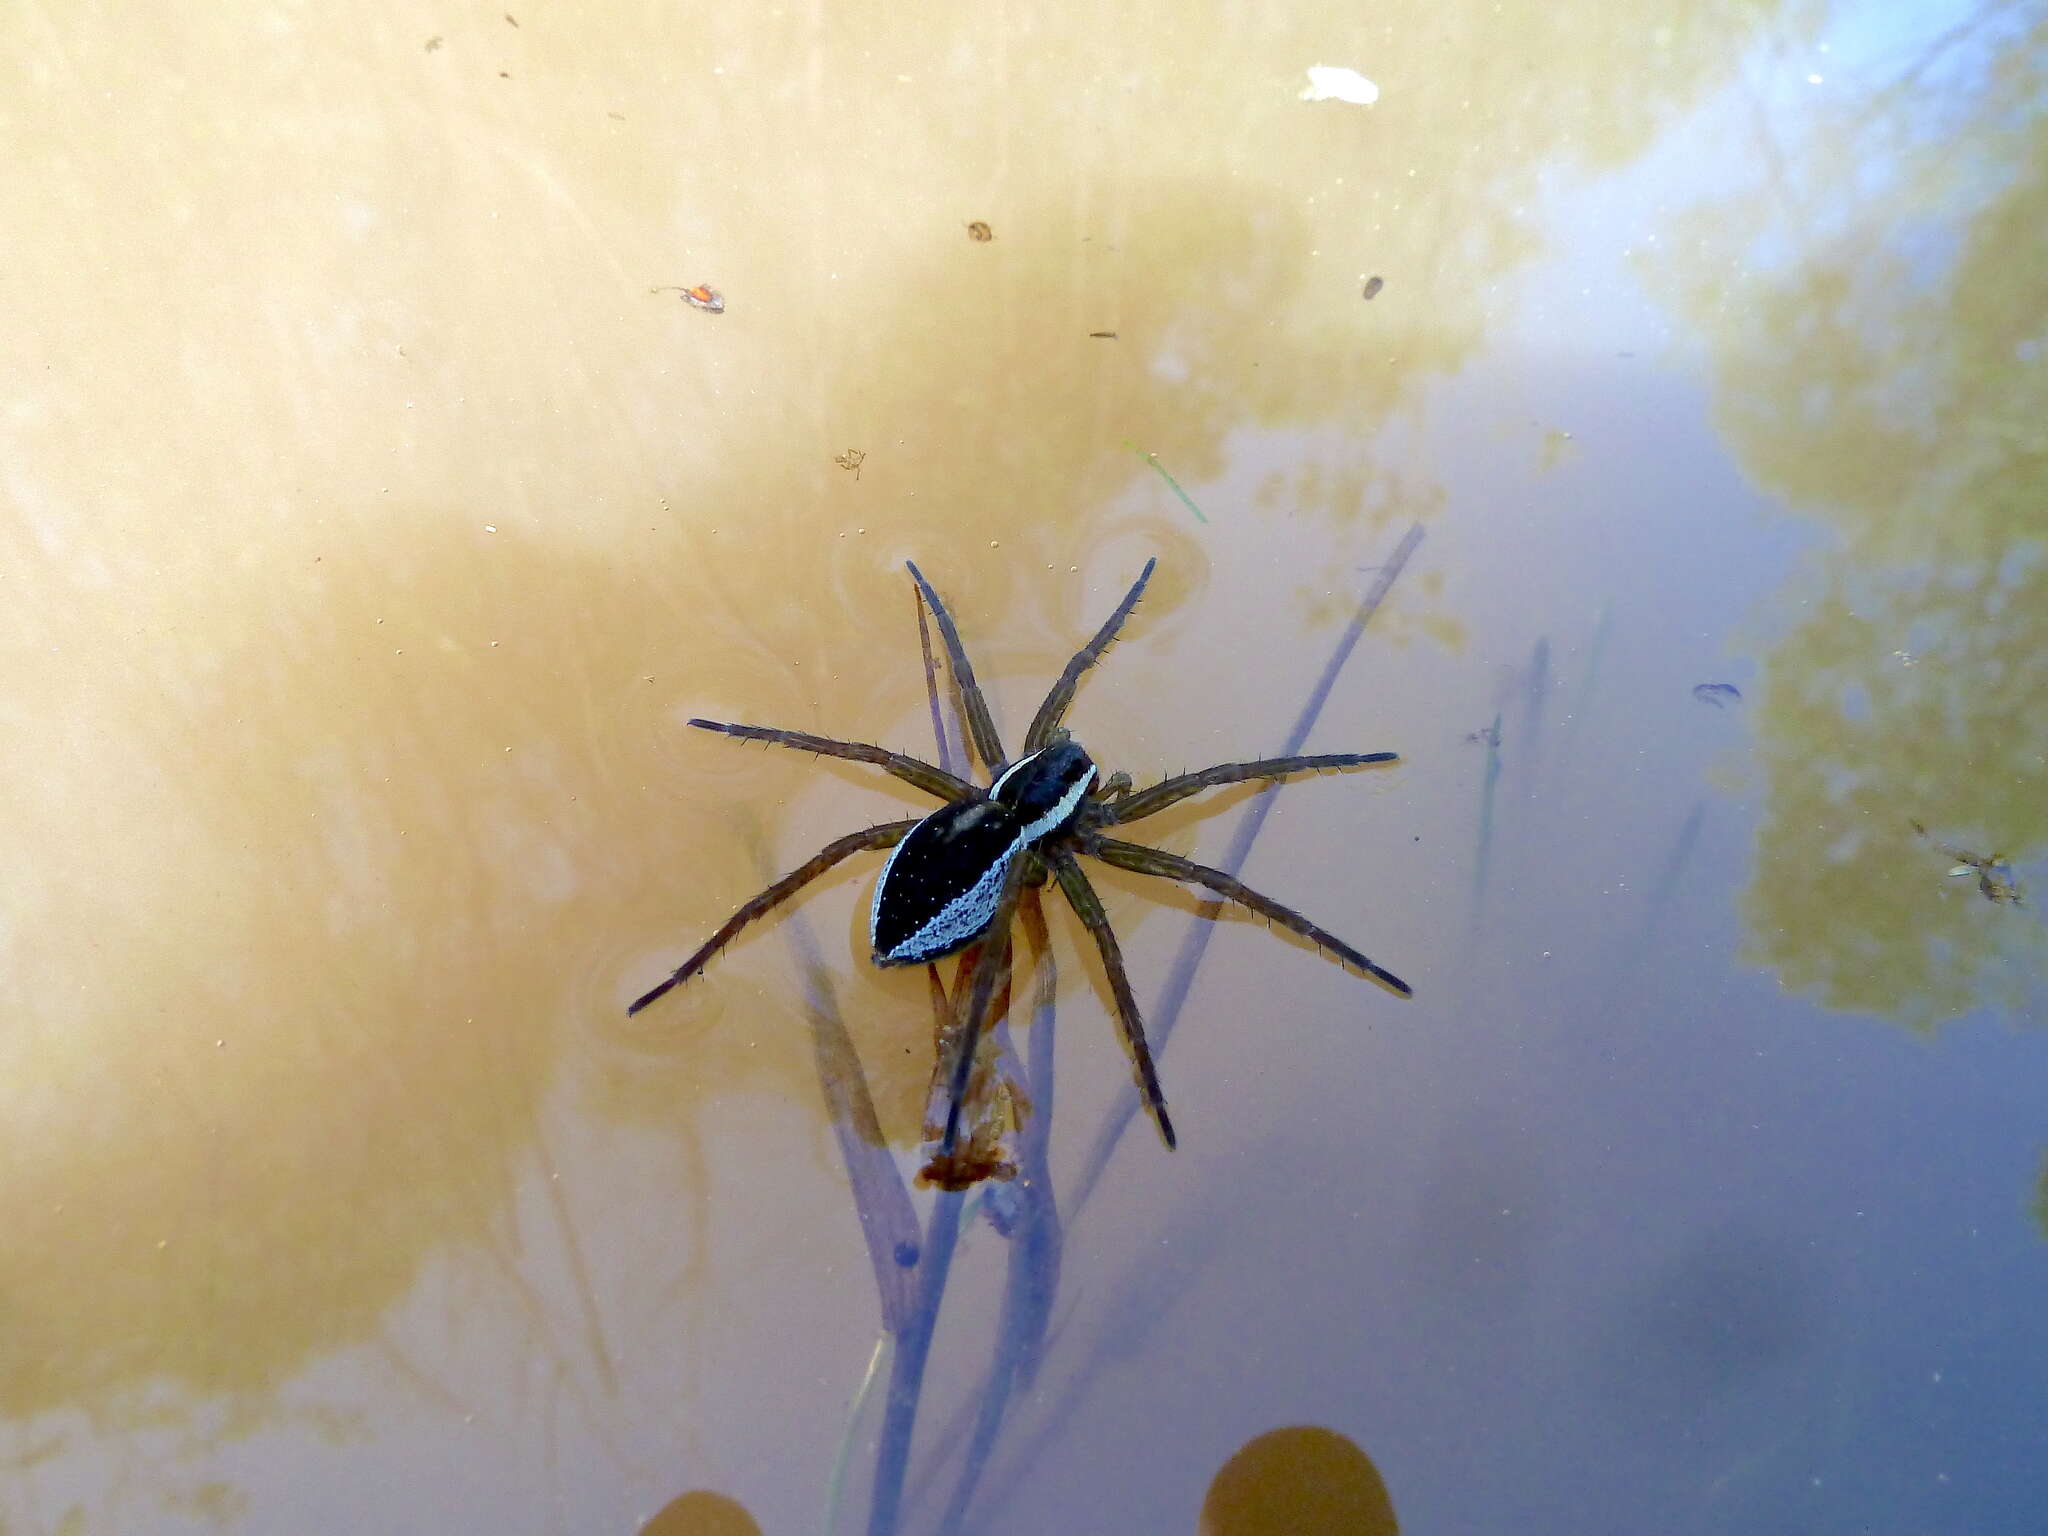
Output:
[627, 561, 1409, 1188]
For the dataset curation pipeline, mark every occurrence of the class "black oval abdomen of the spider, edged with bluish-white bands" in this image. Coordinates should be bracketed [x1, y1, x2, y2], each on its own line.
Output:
[868, 801, 1028, 965]
